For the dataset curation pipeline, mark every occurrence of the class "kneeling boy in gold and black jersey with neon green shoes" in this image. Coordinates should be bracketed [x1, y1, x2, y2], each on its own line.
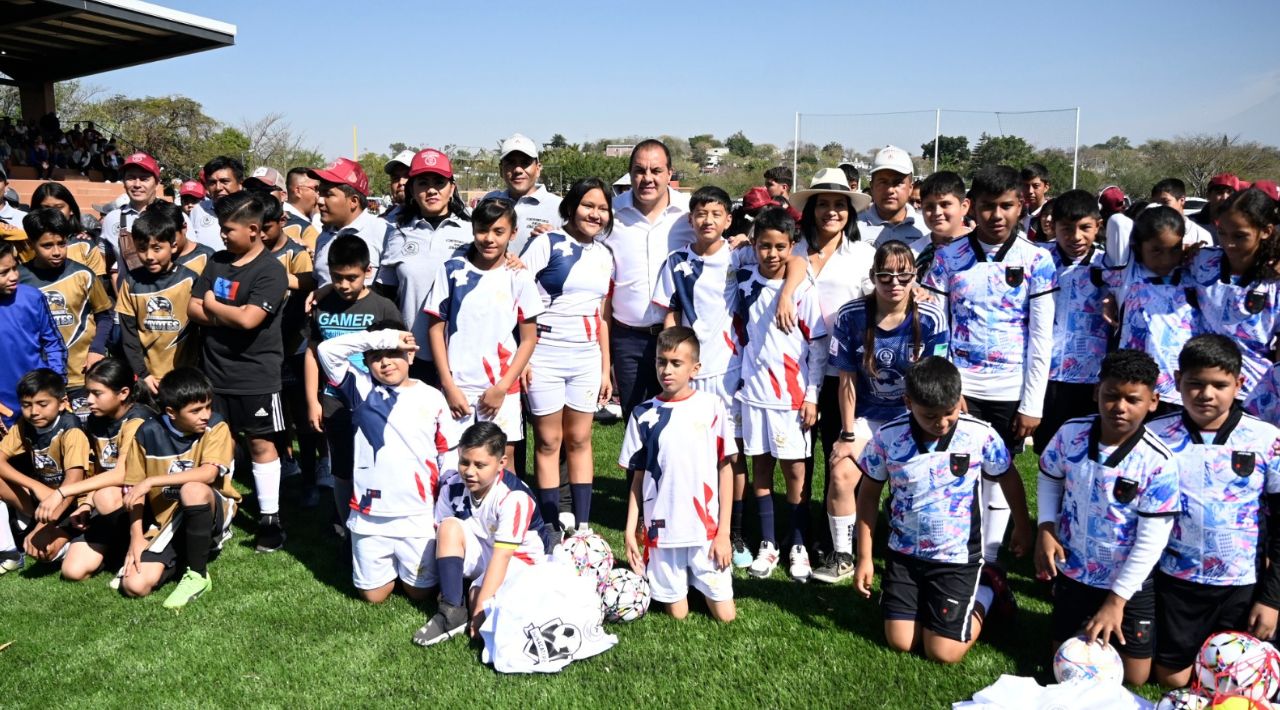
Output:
[120, 367, 241, 609]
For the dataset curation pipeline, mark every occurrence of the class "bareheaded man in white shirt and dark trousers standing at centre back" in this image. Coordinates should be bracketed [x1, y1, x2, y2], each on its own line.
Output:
[602, 138, 694, 420]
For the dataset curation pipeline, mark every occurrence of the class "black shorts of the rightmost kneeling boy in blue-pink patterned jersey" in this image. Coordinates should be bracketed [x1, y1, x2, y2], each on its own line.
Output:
[1156, 574, 1253, 670]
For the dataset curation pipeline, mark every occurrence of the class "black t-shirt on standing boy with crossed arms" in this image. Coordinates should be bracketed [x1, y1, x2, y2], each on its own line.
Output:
[191, 249, 289, 394]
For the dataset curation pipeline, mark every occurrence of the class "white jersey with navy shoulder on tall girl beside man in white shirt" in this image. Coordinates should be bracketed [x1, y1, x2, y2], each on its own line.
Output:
[520, 232, 613, 345]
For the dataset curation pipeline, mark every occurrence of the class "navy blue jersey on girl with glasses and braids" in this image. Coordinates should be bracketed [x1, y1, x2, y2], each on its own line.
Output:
[831, 298, 948, 421]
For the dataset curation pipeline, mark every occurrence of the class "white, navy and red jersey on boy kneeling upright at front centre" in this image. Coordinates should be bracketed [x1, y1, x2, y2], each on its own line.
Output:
[618, 390, 737, 548]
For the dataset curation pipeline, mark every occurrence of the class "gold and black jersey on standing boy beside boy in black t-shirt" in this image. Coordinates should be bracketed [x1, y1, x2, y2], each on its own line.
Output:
[115, 266, 200, 380]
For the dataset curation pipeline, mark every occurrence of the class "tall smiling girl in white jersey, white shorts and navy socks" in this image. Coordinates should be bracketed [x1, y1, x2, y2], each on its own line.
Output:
[521, 178, 613, 530]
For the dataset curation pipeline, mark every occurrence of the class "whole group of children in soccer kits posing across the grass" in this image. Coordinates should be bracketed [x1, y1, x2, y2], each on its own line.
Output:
[0, 144, 1280, 684]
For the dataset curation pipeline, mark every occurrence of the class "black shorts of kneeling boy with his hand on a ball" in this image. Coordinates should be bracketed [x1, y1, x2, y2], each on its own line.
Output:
[1051, 574, 1156, 659]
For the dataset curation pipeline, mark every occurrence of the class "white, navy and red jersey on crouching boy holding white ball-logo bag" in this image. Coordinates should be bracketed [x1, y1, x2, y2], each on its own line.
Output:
[435, 471, 547, 564]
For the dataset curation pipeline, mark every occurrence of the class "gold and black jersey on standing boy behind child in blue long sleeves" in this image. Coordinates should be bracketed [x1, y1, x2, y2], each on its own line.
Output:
[19, 260, 111, 389]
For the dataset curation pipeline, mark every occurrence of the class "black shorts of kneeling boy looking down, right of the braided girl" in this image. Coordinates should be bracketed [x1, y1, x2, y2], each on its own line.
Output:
[881, 550, 982, 643]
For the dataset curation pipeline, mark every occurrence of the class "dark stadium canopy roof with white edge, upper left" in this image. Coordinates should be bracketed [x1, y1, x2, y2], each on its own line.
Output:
[0, 0, 236, 85]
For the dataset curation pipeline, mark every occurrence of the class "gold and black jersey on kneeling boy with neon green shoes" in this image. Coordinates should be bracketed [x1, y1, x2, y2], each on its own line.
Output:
[123, 414, 241, 539]
